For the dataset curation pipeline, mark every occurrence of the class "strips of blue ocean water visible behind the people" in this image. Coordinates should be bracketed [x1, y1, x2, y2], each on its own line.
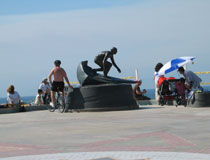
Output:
[0, 86, 210, 104]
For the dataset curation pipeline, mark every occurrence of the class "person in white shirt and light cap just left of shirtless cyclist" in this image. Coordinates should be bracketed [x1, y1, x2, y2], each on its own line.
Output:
[39, 78, 51, 104]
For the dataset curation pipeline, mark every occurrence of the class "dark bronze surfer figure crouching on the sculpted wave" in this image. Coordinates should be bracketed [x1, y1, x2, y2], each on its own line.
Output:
[93, 47, 121, 77]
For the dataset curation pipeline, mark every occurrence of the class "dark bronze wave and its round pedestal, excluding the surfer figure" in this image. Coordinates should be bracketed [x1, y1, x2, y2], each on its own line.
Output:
[67, 61, 138, 111]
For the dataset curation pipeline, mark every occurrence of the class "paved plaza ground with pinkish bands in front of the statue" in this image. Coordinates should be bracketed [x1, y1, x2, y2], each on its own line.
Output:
[0, 105, 210, 160]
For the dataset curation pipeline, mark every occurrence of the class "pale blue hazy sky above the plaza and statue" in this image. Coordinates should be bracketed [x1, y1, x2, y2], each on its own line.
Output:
[0, 0, 210, 97]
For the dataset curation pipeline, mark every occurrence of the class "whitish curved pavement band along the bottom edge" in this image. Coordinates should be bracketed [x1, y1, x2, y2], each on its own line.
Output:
[0, 152, 210, 160]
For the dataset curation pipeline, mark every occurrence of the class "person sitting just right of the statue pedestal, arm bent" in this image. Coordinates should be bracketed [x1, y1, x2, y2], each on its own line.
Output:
[133, 81, 150, 100]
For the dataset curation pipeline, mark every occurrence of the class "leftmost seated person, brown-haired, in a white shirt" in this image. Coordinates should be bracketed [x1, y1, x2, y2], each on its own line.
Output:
[7, 85, 25, 112]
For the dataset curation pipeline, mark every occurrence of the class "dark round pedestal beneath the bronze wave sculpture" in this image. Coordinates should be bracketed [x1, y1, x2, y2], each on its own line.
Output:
[66, 84, 138, 111]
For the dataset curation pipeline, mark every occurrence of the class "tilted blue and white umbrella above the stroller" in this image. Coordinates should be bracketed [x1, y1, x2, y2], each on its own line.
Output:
[157, 57, 195, 76]
